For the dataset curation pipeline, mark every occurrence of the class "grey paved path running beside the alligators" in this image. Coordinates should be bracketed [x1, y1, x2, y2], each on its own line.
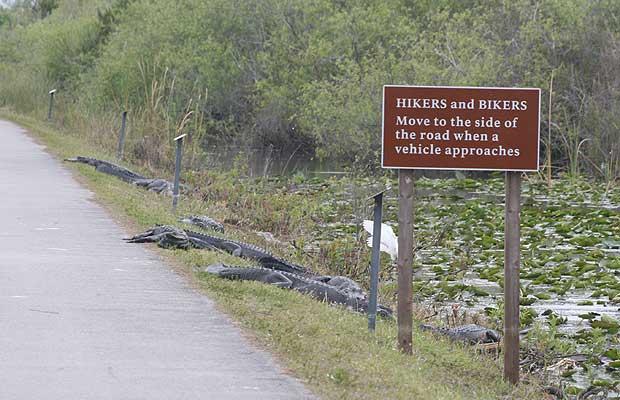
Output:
[0, 121, 310, 400]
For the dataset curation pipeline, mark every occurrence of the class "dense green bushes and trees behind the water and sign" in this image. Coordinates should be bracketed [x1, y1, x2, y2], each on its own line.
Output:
[0, 0, 620, 180]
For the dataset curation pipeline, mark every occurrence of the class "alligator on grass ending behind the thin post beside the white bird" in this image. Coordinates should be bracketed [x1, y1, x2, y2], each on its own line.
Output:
[203, 264, 392, 318]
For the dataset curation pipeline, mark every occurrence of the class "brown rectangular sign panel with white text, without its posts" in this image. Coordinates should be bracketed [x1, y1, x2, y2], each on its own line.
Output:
[382, 85, 540, 171]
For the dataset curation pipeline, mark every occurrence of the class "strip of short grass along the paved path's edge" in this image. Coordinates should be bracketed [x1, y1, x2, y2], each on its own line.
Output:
[0, 110, 542, 400]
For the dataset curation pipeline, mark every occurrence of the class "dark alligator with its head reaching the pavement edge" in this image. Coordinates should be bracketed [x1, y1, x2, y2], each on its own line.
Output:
[125, 225, 308, 274]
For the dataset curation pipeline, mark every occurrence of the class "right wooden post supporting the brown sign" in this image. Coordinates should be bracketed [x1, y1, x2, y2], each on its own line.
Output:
[504, 171, 521, 384]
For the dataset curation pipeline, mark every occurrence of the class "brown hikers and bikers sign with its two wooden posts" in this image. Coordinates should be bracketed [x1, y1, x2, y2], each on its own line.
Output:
[382, 85, 540, 384]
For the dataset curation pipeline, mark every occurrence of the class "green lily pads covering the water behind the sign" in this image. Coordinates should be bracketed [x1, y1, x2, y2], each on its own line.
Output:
[284, 177, 620, 390]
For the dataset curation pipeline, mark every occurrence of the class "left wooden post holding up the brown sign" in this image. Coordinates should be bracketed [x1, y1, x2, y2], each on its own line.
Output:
[397, 169, 414, 354]
